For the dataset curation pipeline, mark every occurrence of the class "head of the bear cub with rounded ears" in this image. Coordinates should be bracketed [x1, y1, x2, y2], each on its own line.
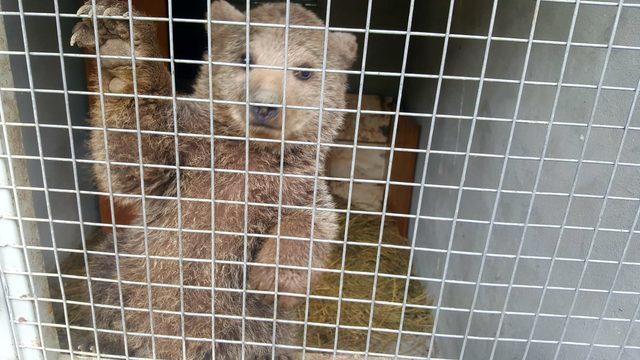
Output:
[200, 1, 357, 142]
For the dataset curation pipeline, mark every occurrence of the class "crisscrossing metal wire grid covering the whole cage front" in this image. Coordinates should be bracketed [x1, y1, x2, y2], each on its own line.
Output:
[0, 0, 640, 360]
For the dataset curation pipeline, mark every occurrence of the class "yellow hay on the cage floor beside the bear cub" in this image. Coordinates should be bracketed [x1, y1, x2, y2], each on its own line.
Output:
[298, 215, 433, 354]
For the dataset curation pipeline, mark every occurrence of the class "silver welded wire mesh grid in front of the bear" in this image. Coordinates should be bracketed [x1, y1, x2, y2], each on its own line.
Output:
[0, 0, 640, 359]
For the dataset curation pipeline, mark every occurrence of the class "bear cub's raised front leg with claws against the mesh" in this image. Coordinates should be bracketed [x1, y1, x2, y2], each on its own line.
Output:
[70, 0, 178, 202]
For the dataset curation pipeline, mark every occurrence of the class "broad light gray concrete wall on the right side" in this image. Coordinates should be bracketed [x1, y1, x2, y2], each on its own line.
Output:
[403, 0, 640, 359]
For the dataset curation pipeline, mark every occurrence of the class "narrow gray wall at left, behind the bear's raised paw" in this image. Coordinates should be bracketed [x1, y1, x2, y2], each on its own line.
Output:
[2, 0, 98, 271]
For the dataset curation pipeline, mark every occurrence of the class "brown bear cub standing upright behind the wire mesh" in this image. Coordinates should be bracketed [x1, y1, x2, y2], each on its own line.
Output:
[64, 0, 357, 359]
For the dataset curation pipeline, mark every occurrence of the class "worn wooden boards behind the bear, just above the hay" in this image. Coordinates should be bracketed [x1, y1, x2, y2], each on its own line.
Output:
[326, 94, 420, 235]
